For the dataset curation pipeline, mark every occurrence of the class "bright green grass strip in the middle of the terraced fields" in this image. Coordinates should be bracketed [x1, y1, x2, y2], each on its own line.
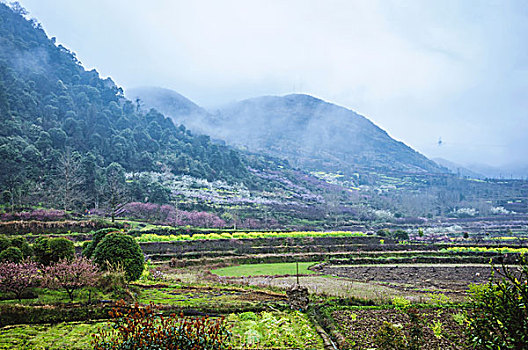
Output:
[211, 262, 317, 277]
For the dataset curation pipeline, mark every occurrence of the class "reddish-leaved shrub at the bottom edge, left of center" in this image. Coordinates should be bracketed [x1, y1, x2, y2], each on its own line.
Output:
[92, 301, 231, 350]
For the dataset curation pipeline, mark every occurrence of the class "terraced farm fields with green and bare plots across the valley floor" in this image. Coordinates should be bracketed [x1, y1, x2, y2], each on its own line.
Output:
[0, 227, 528, 349]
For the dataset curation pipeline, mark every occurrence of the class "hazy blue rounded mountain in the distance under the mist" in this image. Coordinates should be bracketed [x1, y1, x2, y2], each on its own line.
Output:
[134, 90, 448, 178]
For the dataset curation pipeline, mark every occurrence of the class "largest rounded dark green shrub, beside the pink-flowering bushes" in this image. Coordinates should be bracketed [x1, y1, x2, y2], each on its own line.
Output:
[93, 232, 145, 281]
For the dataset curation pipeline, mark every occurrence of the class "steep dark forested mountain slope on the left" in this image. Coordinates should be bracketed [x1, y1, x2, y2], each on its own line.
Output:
[0, 3, 255, 207]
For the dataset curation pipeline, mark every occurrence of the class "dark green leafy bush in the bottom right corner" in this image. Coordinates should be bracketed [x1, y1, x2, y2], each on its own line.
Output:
[468, 254, 528, 350]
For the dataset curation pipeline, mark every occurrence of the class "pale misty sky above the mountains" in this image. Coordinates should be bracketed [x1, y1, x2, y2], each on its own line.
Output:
[14, 0, 528, 170]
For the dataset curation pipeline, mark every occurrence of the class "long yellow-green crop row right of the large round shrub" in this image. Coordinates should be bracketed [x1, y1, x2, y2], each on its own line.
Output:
[136, 231, 366, 242]
